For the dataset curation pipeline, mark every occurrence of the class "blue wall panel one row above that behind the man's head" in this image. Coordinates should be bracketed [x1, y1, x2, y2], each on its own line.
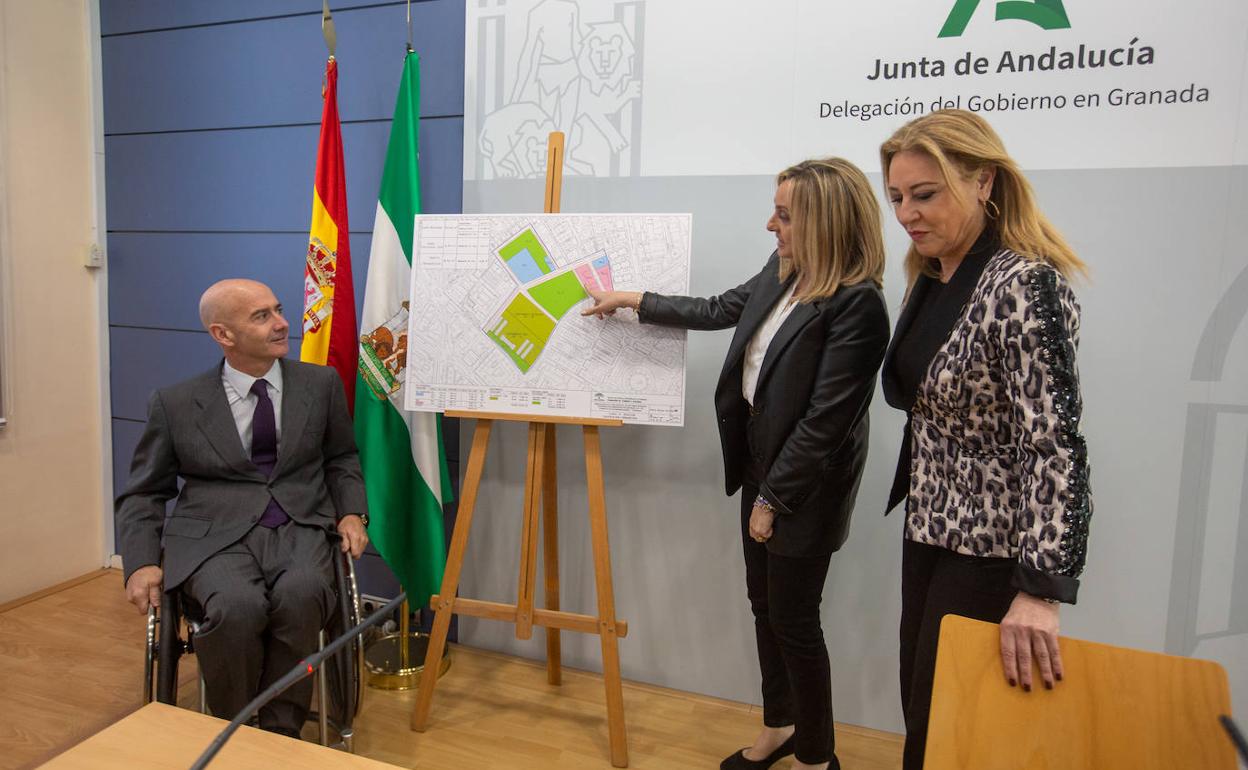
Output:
[105, 117, 463, 232]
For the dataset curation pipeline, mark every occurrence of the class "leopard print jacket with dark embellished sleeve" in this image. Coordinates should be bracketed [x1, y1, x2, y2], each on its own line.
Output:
[906, 250, 1092, 602]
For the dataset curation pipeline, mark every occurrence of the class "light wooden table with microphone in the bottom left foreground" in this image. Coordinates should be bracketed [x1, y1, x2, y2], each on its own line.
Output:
[42, 703, 394, 770]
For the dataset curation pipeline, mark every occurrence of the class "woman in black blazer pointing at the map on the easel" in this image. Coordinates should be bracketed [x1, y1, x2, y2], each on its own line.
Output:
[584, 158, 889, 769]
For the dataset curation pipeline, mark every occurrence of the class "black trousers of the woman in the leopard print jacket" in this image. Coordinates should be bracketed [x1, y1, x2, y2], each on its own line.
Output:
[901, 540, 1018, 770]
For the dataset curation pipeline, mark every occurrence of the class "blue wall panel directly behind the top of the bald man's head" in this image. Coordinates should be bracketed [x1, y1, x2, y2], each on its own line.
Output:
[109, 230, 372, 337]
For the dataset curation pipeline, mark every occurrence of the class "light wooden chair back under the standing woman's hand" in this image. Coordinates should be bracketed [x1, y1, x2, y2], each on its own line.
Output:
[924, 615, 1236, 770]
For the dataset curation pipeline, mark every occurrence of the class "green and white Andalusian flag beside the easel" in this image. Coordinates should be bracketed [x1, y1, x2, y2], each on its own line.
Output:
[356, 51, 451, 607]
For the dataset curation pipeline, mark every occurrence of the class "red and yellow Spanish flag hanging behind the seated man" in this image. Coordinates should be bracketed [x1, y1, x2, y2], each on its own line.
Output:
[300, 56, 357, 404]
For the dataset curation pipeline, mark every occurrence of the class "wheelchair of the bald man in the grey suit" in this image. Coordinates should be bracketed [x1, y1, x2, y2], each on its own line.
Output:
[144, 548, 364, 751]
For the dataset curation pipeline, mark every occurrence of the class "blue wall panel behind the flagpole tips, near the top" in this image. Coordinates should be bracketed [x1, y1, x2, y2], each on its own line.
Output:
[104, 1, 464, 134]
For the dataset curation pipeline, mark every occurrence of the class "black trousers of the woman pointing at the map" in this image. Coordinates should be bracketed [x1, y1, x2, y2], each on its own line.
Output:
[741, 474, 840, 770]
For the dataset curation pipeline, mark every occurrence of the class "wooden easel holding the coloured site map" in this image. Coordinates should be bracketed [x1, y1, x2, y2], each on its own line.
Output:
[412, 131, 628, 768]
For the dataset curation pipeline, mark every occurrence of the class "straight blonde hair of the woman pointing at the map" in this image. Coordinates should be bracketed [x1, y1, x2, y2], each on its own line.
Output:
[776, 157, 884, 302]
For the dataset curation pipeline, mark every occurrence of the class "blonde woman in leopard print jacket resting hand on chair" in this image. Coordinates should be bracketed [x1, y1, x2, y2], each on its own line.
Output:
[880, 110, 1092, 769]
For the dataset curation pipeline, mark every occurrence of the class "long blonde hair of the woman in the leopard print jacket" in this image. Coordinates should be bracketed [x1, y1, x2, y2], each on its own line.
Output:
[880, 110, 1088, 283]
